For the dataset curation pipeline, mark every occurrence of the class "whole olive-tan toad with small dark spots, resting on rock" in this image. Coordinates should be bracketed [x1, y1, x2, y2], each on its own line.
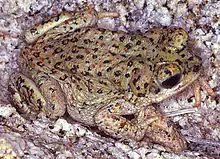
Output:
[9, 7, 215, 151]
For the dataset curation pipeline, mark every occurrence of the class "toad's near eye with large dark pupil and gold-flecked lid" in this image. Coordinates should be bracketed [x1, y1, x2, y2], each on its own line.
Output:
[157, 63, 182, 89]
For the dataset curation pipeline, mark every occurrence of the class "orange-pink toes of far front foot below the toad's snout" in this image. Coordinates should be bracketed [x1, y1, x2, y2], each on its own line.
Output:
[194, 78, 216, 107]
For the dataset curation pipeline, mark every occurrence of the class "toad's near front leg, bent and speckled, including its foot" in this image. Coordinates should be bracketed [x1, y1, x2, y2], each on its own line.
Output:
[95, 100, 186, 152]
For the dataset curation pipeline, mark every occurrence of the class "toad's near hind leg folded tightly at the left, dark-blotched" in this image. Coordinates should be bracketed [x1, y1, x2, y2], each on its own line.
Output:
[9, 73, 66, 118]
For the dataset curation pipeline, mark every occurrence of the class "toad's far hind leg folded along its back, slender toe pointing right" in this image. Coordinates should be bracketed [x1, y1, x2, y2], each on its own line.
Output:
[25, 6, 119, 43]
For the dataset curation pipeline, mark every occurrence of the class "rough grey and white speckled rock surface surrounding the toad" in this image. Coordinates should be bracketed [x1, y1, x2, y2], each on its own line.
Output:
[0, 0, 220, 159]
